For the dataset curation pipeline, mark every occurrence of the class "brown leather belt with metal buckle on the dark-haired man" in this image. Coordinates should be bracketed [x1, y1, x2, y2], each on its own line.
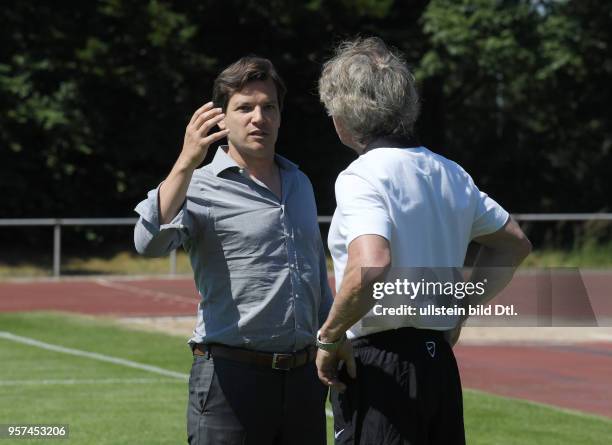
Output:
[193, 343, 317, 371]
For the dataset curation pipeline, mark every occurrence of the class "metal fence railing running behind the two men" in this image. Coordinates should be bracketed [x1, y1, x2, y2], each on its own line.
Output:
[0, 213, 612, 277]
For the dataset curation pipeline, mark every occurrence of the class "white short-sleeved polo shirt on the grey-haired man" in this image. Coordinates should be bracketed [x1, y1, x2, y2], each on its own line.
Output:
[328, 147, 509, 338]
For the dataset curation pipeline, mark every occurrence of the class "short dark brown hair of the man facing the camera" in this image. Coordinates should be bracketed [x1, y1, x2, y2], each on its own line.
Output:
[212, 56, 287, 111]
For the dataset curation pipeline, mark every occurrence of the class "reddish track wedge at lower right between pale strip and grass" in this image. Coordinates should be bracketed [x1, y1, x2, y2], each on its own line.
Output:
[455, 343, 612, 417]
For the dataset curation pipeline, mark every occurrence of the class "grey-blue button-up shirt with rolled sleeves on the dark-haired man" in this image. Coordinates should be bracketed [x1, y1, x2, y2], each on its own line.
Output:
[134, 147, 332, 352]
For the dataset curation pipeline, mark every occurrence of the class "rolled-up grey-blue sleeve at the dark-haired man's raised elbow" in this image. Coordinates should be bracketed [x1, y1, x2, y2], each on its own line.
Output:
[134, 187, 193, 257]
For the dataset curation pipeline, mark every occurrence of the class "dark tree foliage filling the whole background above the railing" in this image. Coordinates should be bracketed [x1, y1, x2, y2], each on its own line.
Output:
[0, 0, 612, 224]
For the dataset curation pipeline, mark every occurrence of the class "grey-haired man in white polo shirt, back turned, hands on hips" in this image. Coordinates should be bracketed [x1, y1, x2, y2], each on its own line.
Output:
[317, 38, 531, 445]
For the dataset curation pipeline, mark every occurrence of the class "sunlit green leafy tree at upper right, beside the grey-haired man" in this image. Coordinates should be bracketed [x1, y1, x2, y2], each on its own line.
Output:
[418, 0, 612, 212]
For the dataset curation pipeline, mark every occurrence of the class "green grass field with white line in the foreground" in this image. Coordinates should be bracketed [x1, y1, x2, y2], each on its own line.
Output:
[0, 313, 612, 445]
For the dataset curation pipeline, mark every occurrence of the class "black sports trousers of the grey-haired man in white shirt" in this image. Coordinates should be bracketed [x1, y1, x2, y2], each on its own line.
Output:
[331, 328, 465, 445]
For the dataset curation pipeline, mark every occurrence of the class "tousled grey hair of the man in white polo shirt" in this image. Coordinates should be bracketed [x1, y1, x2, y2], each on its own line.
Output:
[319, 37, 419, 143]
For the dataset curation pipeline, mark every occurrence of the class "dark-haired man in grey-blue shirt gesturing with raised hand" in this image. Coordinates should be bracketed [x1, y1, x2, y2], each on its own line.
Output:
[134, 57, 332, 445]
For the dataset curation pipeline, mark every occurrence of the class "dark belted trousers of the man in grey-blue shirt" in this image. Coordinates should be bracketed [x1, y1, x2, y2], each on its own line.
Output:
[187, 355, 327, 445]
